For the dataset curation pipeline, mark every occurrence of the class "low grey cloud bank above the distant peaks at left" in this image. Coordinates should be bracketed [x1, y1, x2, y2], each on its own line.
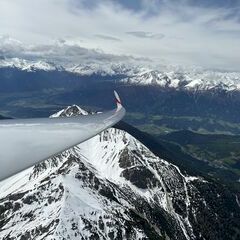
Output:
[0, 36, 150, 66]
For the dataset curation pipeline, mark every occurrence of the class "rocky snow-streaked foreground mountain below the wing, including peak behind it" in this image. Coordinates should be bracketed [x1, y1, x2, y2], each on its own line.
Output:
[0, 105, 240, 240]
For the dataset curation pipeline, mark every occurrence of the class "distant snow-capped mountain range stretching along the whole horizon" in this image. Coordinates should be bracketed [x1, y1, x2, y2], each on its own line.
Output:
[0, 58, 240, 91]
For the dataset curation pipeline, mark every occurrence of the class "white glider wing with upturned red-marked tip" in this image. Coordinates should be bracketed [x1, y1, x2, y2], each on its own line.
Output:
[0, 92, 125, 181]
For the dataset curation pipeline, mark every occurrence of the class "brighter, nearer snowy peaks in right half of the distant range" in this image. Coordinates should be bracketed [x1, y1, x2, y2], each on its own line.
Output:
[123, 70, 240, 91]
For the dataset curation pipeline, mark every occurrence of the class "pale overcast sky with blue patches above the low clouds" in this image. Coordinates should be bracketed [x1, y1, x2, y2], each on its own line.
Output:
[0, 0, 240, 71]
